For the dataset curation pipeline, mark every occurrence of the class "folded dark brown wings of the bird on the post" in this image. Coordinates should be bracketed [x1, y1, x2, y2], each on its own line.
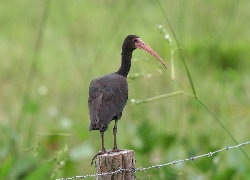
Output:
[88, 75, 128, 131]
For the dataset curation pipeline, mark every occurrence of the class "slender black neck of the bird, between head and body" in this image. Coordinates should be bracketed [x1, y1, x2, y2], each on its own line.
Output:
[116, 48, 133, 77]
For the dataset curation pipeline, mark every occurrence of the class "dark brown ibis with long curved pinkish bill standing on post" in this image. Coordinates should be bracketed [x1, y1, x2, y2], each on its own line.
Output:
[88, 35, 166, 154]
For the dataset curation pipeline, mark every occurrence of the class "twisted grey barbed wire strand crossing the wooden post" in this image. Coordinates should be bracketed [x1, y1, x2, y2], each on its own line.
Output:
[56, 141, 250, 180]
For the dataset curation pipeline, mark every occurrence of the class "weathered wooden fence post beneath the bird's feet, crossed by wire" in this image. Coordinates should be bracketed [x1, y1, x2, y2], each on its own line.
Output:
[95, 150, 135, 180]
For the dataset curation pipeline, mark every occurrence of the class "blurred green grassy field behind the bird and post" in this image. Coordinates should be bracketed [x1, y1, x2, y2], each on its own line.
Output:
[0, 0, 250, 179]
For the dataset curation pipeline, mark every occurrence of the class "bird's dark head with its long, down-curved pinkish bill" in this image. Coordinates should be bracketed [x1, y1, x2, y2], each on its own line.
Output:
[123, 35, 167, 68]
